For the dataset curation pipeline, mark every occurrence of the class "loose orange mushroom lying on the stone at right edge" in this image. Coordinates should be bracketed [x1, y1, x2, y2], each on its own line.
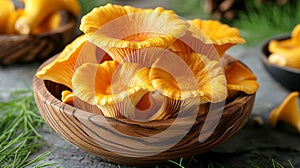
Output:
[269, 92, 300, 132]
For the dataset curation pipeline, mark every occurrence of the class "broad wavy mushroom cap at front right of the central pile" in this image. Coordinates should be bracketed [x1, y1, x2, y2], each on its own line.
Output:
[149, 53, 227, 103]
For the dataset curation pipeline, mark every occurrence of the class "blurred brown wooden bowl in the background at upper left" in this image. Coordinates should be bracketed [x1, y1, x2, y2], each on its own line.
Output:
[0, 12, 77, 65]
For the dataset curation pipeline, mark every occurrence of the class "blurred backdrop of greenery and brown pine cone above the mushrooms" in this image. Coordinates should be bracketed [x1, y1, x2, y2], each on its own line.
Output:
[79, 0, 300, 46]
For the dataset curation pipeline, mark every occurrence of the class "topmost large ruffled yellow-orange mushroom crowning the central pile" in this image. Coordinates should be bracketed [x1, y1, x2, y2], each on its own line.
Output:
[80, 4, 188, 63]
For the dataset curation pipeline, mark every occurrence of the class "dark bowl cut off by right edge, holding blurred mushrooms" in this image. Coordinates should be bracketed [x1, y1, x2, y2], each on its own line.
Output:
[260, 35, 300, 91]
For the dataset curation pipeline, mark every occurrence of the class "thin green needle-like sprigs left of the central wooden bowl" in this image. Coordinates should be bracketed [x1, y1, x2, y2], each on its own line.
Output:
[0, 90, 53, 168]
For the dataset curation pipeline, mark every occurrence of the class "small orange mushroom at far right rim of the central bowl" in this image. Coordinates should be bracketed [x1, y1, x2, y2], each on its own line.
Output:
[224, 61, 259, 94]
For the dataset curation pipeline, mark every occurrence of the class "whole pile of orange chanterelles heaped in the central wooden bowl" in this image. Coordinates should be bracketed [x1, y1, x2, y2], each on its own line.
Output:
[37, 4, 259, 121]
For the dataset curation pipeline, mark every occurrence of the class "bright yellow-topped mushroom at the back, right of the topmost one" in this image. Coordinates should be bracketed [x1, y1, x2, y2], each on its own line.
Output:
[173, 19, 246, 59]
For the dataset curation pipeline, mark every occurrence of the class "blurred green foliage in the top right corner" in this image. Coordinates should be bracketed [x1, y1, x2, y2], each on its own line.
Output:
[233, 1, 300, 45]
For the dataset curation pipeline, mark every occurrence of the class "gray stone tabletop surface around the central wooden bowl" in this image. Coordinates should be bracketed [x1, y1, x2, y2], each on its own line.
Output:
[0, 46, 300, 168]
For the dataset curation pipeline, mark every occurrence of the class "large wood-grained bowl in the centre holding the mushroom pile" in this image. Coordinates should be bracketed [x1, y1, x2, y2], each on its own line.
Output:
[33, 54, 255, 166]
